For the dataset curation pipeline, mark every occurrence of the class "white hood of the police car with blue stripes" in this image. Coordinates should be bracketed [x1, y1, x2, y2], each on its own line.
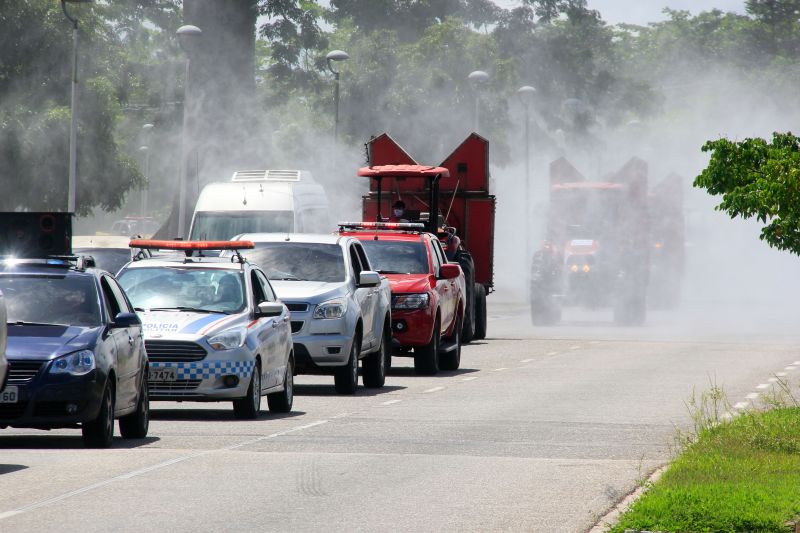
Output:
[139, 311, 247, 339]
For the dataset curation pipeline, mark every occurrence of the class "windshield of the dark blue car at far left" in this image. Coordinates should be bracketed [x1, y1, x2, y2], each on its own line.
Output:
[0, 274, 101, 327]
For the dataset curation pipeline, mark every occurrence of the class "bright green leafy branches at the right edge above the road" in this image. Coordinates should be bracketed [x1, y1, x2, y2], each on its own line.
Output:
[694, 133, 800, 255]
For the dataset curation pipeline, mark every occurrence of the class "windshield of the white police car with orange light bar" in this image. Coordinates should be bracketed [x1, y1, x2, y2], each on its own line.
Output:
[117, 266, 245, 313]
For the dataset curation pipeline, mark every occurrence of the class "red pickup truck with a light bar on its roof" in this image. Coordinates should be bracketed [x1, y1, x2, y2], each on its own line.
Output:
[339, 222, 466, 374]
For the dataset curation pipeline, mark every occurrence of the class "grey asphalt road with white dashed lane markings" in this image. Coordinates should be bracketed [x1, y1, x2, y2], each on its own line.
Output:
[0, 299, 800, 532]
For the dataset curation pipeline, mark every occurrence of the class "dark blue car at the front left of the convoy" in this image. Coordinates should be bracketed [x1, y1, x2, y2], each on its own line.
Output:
[0, 259, 150, 447]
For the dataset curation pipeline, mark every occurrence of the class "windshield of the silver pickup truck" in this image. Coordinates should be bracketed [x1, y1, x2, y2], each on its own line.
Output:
[246, 242, 345, 283]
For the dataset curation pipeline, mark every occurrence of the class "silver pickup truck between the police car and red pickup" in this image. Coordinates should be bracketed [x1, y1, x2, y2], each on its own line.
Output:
[230, 233, 392, 394]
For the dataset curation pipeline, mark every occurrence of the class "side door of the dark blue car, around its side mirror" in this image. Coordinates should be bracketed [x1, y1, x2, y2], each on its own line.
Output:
[100, 275, 139, 410]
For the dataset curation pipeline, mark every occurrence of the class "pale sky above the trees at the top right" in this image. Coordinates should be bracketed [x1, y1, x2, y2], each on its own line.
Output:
[495, 0, 744, 25]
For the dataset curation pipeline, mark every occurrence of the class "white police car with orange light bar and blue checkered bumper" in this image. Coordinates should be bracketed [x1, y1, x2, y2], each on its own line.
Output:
[118, 239, 294, 419]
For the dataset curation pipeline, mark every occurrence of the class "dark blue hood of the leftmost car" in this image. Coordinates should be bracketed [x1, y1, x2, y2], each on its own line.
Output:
[6, 325, 103, 360]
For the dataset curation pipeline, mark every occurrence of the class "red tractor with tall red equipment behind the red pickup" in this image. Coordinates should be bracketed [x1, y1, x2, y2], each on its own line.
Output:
[358, 133, 495, 342]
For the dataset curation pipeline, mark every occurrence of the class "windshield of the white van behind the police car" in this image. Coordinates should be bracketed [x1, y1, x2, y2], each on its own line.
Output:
[191, 211, 294, 241]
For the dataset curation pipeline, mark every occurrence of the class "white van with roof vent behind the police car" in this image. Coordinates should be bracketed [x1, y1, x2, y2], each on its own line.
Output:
[189, 170, 332, 241]
